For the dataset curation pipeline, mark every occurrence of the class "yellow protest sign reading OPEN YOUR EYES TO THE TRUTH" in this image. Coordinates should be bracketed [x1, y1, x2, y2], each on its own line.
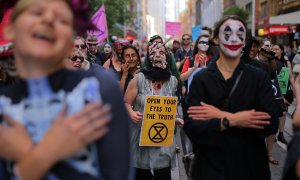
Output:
[140, 96, 177, 146]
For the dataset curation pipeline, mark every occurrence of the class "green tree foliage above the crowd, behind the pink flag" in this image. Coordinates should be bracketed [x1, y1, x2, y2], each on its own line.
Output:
[89, 0, 134, 36]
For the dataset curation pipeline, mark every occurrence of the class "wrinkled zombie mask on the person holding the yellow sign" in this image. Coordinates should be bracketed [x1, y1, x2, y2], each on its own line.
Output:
[149, 43, 168, 69]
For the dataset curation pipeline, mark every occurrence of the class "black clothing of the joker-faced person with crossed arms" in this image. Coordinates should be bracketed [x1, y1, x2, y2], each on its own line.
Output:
[184, 61, 278, 180]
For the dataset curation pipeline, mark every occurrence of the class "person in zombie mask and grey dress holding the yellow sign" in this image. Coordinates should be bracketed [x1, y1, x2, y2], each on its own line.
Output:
[124, 42, 177, 180]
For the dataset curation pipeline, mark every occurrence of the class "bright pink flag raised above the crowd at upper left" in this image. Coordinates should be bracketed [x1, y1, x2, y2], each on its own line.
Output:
[87, 4, 108, 44]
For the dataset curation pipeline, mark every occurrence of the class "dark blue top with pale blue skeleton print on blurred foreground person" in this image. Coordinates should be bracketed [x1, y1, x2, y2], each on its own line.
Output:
[0, 69, 130, 180]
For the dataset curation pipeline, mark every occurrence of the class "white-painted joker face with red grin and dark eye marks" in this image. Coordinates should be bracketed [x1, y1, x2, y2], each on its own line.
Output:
[219, 19, 246, 58]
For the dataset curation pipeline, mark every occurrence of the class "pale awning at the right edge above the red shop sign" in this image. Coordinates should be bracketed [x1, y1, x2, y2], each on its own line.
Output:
[270, 11, 300, 24]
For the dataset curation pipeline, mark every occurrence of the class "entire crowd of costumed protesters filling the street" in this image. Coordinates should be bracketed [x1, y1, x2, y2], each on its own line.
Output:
[0, 0, 300, 180]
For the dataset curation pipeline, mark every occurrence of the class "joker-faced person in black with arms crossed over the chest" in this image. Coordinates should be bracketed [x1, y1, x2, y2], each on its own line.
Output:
[184, 16, 278, 180]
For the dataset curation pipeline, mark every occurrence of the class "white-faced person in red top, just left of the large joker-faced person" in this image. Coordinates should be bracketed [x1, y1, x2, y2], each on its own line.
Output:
[180, 35, 211, 81]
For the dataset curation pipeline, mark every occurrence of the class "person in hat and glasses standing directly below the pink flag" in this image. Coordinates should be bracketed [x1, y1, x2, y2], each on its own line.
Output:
[86, 34, 105, 66]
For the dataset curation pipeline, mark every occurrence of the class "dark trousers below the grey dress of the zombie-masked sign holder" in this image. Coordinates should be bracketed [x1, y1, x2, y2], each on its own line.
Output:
[136, 167, 171, 180]
